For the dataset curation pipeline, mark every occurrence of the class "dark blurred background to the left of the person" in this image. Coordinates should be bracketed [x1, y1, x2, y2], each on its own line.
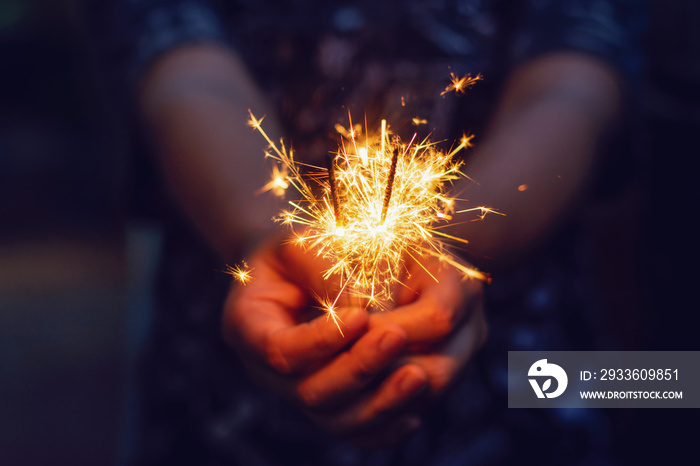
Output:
[0, 0, 127, 466]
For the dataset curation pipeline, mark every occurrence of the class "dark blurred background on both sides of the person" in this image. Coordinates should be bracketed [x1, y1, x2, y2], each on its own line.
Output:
[0, 0, 700, 466]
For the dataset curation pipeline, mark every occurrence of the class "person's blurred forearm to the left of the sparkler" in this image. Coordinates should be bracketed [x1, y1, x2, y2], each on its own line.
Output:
[139, 45, 278, 259]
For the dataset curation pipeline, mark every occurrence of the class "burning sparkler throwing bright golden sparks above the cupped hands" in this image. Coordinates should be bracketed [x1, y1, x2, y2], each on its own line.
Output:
[239, 105, 498, 329]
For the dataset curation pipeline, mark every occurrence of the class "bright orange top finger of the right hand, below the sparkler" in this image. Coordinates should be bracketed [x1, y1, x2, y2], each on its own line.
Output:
[370, 275, 483, 344]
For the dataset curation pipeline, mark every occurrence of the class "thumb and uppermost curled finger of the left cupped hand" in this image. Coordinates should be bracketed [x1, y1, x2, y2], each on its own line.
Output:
[222, 238, 367, 374]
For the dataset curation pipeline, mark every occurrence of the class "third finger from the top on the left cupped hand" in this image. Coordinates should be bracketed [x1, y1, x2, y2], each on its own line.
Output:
[325, 364, 428, 437]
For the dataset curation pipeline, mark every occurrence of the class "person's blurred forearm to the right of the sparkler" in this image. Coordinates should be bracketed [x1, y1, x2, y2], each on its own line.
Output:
[460, 54, 620, 270]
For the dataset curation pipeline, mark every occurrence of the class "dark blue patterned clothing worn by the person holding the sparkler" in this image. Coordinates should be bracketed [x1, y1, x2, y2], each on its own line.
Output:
[104, 0, 645, 466]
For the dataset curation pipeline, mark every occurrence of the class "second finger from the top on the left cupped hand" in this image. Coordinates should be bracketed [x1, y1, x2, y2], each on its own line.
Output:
[297, 326, 406, 410]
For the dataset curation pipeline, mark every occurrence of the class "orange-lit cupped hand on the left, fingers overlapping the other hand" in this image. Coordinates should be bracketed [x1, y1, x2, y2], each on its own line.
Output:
[223, 238, 429, 445]
